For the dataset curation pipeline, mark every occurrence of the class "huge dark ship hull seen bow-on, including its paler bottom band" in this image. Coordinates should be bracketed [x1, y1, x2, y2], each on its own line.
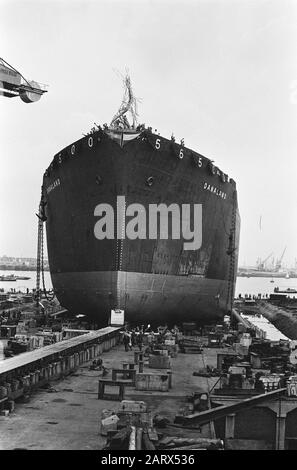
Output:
[43, 130, 240, 324]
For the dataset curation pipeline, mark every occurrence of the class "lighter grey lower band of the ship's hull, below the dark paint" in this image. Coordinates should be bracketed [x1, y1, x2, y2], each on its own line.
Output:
[52, 271, 228, 324]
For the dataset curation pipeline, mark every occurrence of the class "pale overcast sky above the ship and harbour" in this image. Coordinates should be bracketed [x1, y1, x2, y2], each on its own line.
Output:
[0, 0, 297, 265]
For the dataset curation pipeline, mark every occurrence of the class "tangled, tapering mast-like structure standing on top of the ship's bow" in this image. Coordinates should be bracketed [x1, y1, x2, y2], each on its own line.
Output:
[109, 74, 138, 130]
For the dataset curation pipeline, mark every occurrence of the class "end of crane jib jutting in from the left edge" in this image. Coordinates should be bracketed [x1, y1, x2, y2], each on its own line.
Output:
[0, 57, 47, 103]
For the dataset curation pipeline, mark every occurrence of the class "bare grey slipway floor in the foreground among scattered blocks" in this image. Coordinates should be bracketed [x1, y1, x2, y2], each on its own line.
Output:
[0, 345, 221, 450]
